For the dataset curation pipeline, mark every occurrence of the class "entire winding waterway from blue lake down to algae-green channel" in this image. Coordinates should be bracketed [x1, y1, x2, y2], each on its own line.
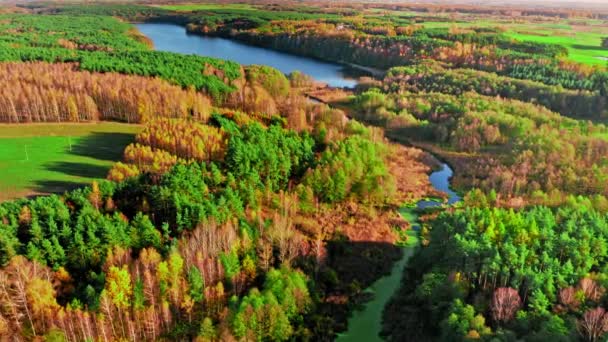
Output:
[137, 23, 460, 342]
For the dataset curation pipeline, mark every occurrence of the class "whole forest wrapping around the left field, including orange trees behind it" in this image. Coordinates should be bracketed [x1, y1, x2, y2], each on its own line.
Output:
[0, 27, 429, 341]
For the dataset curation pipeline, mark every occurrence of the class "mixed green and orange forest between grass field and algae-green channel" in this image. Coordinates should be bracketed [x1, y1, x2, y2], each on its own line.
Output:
[0, 107, 428, 340]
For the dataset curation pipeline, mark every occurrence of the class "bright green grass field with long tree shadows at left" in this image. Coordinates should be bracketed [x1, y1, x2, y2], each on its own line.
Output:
[0, 123, 140, 201]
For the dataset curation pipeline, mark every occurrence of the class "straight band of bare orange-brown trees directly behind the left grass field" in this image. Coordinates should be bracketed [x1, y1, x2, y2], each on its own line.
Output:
[0, 62, 211, 123]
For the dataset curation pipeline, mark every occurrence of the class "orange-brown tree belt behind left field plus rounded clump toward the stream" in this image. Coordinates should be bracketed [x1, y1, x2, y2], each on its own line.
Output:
[0, 61, 312, 124]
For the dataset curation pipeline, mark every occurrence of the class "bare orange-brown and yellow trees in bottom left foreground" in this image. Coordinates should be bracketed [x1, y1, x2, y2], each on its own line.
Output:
[0, 220, 240, 341]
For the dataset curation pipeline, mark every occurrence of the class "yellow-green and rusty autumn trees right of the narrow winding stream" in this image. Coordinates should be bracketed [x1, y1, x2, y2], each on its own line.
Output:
[354, 89, 608, 203]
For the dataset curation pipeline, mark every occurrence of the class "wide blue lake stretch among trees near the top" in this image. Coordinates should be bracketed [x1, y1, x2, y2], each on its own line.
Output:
[136, 23, 360, 88]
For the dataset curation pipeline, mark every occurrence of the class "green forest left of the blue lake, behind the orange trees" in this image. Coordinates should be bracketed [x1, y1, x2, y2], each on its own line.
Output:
[0, 15, 242, 101]
